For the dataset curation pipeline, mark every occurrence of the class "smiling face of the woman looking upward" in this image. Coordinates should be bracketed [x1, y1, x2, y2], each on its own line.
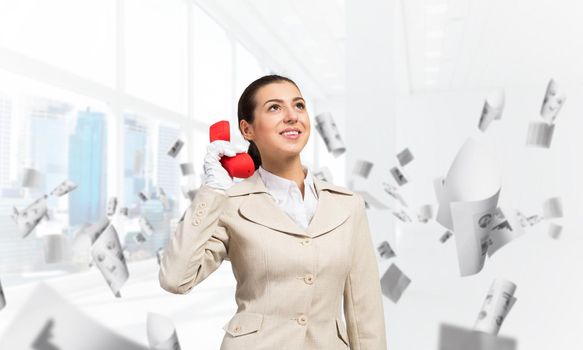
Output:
[247, 81, 310, 159]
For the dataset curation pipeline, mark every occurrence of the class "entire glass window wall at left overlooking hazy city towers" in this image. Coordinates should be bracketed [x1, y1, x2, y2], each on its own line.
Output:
[0, 0, 268, 285]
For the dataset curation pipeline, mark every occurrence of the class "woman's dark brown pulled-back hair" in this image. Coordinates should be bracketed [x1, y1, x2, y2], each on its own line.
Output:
[237, 74, 299, 170]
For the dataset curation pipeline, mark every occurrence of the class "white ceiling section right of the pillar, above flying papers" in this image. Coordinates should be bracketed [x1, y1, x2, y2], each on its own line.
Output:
[401, 0, 583, 92]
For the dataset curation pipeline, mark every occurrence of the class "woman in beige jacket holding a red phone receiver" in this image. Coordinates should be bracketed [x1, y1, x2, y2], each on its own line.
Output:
[160, 75, 386, 350]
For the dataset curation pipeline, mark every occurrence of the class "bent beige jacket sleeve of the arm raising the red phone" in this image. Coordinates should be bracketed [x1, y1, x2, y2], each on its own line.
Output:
[158, 185, 229, 294]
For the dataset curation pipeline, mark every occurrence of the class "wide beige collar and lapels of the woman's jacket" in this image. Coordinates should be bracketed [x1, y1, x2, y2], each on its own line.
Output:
[227, 171, 354, 237]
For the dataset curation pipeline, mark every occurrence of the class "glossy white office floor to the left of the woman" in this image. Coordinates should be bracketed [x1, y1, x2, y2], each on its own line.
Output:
[0, 258, 236, 349]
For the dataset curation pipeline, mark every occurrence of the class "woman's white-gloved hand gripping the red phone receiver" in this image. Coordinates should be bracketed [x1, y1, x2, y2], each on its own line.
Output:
[203, 140, 246, 190]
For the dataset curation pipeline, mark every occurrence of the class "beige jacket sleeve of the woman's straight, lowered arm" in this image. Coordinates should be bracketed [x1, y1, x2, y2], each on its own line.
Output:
[344, 194, 387, 350]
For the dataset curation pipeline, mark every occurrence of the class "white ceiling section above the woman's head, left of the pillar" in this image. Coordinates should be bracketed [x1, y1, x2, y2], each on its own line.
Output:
[196, 0, 346, 97]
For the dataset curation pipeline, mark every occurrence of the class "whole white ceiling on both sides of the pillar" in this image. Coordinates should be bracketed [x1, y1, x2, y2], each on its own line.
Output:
[197, 0, 583, 97]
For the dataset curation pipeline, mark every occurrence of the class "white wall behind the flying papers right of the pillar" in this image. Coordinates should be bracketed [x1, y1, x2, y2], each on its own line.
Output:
[388, 83, 583, 350]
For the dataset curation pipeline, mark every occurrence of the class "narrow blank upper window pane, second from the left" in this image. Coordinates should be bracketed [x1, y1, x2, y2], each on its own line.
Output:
[124, 0, 188, 113]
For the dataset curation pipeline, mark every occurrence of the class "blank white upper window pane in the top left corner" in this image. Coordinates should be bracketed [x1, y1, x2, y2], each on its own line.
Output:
[0, 0, 117, 87]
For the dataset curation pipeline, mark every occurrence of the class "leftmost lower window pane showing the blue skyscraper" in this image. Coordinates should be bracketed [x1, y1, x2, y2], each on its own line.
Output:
[0, 71, 108, 273]
